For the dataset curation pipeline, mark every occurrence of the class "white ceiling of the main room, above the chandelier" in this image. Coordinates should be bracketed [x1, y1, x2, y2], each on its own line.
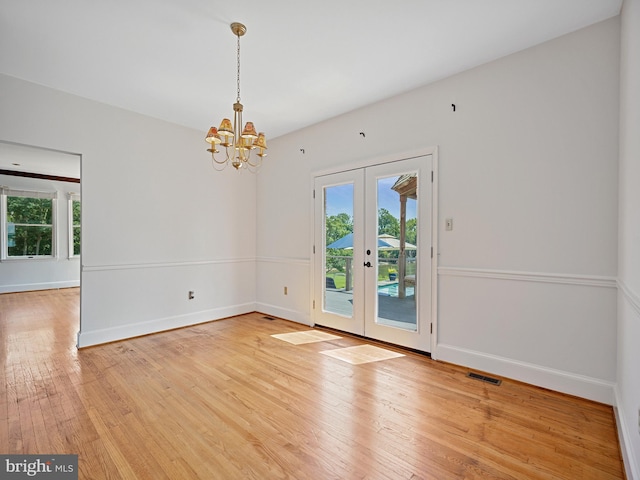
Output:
[0, 0, 622, 145]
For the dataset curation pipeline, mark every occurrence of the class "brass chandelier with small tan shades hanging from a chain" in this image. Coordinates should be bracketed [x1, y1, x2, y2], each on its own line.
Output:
[205, 22, 267, 171]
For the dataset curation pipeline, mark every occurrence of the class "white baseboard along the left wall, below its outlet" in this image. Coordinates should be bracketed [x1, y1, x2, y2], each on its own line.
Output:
[78, 303, 256, 348]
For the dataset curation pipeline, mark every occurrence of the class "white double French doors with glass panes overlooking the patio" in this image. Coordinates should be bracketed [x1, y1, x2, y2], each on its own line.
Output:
[313, 155, 432, 352]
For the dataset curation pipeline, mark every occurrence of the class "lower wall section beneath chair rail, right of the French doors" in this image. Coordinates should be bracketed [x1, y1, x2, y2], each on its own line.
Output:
[434, 267, 617, 404]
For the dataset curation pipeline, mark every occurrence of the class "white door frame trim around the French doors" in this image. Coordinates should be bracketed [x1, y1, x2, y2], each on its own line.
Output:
[309, 146, 440, 360]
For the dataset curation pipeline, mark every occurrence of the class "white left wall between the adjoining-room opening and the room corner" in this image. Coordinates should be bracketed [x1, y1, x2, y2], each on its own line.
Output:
[0, 76, 256, 346]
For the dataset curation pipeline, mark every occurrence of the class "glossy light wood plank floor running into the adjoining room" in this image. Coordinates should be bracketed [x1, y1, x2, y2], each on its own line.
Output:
[0, 289, 624, 480]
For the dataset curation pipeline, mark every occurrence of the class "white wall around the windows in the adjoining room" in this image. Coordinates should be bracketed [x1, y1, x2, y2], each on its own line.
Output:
[0, 172, 80, 293]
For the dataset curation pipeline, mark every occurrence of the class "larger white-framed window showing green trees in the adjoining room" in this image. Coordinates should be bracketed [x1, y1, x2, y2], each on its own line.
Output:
[2, 188, 56, 259]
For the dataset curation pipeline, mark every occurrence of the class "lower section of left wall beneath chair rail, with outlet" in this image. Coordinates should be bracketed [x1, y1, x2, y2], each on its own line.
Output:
[78, 259, 256, 347]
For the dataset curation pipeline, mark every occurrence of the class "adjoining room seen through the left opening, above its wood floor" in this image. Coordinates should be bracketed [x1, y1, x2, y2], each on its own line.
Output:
[0, 140, 82, 344]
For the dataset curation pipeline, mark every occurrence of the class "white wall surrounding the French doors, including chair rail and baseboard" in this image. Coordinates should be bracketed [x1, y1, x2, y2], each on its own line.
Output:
[257, 18, 619, 403]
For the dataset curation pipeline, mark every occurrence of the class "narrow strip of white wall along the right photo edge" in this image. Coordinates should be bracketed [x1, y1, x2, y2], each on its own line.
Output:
[616, 0, 640, 480]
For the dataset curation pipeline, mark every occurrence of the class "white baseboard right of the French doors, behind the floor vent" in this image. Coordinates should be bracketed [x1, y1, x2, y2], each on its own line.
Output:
[432, 344, 615, 405]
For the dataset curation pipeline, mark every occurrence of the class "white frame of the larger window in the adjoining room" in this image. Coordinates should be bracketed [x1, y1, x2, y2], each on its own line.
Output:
[0, 187, 58, 261]
